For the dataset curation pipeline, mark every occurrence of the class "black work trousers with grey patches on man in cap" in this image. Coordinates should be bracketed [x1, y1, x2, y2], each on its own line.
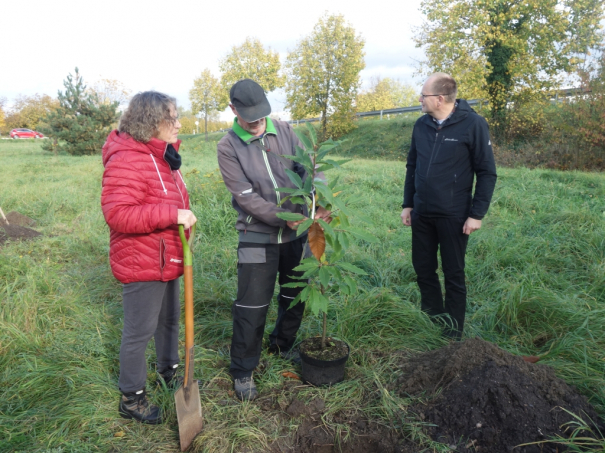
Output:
[230, 237, 306, 379]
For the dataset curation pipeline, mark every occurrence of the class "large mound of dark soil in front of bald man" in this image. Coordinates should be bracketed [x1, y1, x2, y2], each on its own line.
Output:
[397, 339, 602, 453]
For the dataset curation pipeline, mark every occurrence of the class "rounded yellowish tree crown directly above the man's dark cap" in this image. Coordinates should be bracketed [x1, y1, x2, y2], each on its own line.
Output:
[219, 37, 284, 94]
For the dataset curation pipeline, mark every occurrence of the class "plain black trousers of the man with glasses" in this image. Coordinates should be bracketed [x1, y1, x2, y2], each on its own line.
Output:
[411, 211, 468, 339]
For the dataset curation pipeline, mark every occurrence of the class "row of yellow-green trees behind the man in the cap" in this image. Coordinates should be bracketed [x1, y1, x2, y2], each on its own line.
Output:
[189, 15, 417, 138]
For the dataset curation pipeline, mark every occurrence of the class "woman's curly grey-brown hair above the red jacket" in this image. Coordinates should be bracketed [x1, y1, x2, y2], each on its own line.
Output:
[118, 91, 176, 143]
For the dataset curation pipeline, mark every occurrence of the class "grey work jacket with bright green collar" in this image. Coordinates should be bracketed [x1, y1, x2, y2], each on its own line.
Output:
[217, 118, 308, 244]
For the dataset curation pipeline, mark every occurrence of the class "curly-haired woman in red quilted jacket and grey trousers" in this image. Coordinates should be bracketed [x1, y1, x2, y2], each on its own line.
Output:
[101, 91, 196, 424]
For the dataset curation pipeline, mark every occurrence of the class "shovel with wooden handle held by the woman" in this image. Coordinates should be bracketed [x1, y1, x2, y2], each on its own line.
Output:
[174, 225, 204, 451]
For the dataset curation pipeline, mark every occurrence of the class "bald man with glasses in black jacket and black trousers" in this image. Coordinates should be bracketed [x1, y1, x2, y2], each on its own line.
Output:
[401, 73, 497, 340]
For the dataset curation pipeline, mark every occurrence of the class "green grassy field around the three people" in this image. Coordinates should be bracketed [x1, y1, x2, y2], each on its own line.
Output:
[0, 133, 605, 453]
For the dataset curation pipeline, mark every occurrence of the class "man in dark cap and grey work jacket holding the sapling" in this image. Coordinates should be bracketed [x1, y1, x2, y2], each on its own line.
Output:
[217, 79, 330, 400]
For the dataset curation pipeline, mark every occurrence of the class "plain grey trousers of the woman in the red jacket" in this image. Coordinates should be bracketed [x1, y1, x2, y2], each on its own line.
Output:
[119, 278, 180, 393]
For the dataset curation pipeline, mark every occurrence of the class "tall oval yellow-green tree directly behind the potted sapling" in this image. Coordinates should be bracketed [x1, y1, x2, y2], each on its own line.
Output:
[285, 15, 365, 138]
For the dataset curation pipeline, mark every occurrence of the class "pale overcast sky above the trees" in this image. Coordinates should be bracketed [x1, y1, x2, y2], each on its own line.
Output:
[0, 0, 422, 118]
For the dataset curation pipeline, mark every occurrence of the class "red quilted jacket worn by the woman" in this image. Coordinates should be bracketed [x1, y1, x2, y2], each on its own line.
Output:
[101, 131, 189, 283]
